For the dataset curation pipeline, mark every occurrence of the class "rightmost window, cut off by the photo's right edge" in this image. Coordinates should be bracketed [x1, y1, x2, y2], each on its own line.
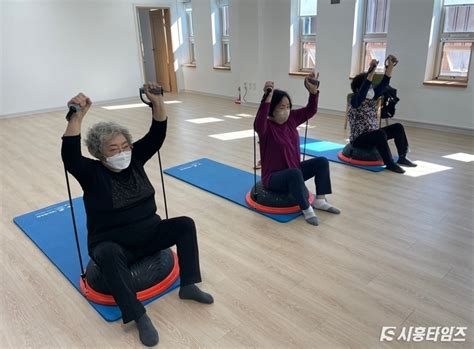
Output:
[435, 0, 474, 81]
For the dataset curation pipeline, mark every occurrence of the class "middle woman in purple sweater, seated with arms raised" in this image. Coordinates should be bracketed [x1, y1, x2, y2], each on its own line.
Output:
[254, 74, 341, 225]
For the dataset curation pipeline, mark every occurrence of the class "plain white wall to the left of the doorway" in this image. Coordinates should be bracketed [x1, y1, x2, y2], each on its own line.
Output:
[0, 0, 182, 114]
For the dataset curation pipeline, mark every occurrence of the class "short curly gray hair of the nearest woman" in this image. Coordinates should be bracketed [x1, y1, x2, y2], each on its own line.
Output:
[85, 122, 132, 160]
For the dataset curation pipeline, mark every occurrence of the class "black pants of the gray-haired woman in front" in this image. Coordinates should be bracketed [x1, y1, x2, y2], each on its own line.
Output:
[91, 216, 201, 323]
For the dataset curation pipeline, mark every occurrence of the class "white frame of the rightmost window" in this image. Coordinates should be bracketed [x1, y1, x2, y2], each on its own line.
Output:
[434, 4, 474, 82]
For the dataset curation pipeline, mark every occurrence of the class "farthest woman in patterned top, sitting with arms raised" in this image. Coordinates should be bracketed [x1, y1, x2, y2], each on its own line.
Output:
[348, 59, 416, 173]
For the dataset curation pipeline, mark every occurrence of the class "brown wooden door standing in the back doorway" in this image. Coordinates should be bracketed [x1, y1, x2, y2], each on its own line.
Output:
[150, 9, 178, 92]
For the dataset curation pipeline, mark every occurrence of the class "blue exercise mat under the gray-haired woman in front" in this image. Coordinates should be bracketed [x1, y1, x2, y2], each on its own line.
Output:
[13, 197, 179, 321]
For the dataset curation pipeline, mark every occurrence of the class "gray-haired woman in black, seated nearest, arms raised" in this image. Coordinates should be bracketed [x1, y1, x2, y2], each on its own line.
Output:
[61, 84, 213, 346]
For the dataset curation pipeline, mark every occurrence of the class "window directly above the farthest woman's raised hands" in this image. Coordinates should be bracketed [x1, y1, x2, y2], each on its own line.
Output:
[362, 0, 390, 72]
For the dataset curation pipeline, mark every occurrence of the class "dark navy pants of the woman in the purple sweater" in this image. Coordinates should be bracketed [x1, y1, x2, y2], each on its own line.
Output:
[268, 157, 332, 210]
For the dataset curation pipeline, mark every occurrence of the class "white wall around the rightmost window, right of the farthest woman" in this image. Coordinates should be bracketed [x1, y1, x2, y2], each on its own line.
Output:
[387, 0, 474, 129]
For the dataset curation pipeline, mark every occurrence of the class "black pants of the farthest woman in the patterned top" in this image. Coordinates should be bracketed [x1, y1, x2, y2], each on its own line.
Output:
[352, 124, 408, 165]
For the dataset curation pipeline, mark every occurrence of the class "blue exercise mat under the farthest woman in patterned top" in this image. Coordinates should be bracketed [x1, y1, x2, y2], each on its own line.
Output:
[300, 137, 385, 172]
